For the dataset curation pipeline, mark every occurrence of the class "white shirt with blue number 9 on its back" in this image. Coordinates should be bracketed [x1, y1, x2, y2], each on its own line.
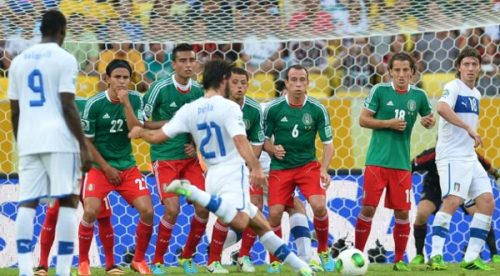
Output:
[8, 43, 79, 156]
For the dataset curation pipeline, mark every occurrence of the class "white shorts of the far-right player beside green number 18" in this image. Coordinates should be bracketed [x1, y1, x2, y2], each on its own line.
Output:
[436, 160, 493, 200]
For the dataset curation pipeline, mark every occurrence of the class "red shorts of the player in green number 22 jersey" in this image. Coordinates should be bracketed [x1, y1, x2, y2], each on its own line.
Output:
[82, 166, 150, 205]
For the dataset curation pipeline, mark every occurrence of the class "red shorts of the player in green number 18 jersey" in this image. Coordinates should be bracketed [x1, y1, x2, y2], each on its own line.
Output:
[363, 166, 411, 210]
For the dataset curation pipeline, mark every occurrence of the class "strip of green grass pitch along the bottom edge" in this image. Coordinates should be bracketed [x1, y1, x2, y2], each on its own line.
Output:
[0, 264, 500, 276]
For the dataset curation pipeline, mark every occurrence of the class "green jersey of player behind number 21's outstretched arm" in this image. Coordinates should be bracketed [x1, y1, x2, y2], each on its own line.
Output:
[144, 75, 203, 161]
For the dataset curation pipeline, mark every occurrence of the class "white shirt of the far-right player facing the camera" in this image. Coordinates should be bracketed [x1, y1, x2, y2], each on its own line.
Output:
[436, 79, 481, 161]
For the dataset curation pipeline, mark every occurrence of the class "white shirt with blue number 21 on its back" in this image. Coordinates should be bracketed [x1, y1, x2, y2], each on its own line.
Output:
[162, 95, 246, 168]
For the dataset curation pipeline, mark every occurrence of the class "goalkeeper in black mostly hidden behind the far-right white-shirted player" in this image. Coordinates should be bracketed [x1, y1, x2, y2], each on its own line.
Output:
[411, 148, 500, 265]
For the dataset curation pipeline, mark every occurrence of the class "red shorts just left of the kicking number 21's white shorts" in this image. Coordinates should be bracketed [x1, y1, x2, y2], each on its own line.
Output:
[153, 158, 205, 202]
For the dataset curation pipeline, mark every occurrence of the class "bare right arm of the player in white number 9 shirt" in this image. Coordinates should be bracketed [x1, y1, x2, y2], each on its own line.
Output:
[59, 93, 92, 172]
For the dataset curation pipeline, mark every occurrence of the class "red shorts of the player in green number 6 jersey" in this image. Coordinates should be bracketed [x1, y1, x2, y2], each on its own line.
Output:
[268, 161, 325, 207]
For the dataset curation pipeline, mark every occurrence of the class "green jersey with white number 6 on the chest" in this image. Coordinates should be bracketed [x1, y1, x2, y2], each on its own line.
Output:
[264, 96, 332, 170]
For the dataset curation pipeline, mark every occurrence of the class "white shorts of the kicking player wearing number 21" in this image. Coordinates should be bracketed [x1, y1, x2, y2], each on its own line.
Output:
[205, 162, 257, 218]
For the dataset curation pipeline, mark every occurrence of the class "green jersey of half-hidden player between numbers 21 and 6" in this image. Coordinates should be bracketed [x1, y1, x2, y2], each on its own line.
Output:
[241, 96, 264, 146]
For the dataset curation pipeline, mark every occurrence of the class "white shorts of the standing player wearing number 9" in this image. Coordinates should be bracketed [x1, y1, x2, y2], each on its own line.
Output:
[19, 152, 82, 203]
